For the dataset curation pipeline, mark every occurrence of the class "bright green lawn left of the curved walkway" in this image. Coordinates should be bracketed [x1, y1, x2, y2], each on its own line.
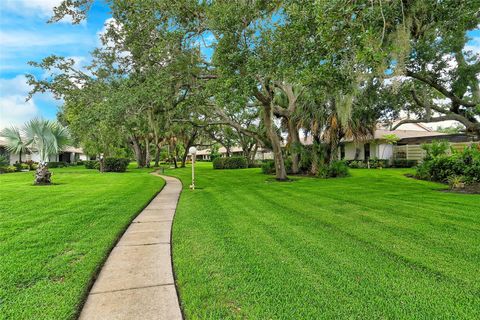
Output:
[0, 167, 164, 320]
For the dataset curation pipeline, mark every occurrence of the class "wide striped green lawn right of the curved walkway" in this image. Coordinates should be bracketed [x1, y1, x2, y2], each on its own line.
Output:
[168, 164, 480, 319]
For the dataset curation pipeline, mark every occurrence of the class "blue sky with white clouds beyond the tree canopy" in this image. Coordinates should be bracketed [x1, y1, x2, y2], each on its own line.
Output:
[0, 0, 480, 129]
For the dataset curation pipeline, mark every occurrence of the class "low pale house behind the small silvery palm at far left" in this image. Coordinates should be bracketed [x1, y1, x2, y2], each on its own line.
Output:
[0, 137, 88, 164]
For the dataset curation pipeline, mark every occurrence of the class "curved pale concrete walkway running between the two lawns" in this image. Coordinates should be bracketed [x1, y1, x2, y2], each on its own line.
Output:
[79, 174, 182, 320]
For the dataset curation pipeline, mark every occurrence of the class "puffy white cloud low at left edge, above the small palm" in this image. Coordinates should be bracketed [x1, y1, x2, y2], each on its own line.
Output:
[0, 75, 39, 129]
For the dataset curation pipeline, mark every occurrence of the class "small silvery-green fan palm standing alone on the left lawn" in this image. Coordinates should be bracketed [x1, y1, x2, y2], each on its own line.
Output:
[23, 118, 70, 184]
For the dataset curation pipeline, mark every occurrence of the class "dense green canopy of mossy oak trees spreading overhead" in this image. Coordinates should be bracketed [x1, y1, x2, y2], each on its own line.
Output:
[29, 0, 480, 180]
